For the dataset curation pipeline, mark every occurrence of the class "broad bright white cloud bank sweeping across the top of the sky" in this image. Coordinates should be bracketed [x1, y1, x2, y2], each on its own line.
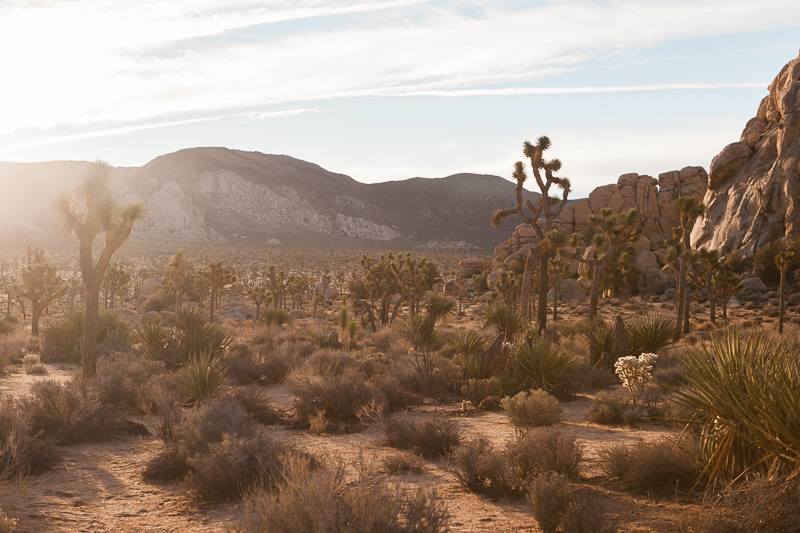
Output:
[0, 0, 800, 133]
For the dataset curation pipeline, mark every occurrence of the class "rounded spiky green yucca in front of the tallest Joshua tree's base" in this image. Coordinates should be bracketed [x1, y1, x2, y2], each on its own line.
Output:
[514, 330, 573, 391]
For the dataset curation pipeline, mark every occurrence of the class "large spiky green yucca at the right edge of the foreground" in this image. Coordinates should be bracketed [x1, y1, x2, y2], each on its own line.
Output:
[676, 328, 800, 479]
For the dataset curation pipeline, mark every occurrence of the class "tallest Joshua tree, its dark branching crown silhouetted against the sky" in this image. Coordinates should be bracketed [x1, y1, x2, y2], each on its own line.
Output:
[491, 137, 570, 333]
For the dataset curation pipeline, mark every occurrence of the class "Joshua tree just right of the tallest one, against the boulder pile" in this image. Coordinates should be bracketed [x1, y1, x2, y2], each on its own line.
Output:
[559, 207, 642, 320]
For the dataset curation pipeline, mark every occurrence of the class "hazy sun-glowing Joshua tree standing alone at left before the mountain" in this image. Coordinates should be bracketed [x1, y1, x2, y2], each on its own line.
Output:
[55, 161, 145, 378]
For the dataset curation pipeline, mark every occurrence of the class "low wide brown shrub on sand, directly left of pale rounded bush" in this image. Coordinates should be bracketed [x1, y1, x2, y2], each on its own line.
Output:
[383, 413, 461, 457]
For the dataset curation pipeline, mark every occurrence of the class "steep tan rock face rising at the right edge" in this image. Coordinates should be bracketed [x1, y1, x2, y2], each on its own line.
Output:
[692, 50, 800, 257]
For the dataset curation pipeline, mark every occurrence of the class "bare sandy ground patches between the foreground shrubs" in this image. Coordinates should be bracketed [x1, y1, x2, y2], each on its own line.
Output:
[0, 365, 693, 533]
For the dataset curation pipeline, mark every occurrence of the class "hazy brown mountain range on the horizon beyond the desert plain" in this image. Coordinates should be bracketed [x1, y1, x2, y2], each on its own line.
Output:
[0, 148, 538, 250]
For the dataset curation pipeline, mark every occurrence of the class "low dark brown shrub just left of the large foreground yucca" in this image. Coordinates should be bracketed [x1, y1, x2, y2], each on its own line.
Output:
[600, 438, 703, 492]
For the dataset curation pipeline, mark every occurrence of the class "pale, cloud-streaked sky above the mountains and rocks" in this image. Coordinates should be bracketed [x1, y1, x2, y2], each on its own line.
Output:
[0, 0, 800, 197]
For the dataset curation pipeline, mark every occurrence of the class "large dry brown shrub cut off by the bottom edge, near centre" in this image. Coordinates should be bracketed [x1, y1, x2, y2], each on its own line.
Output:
[236, 459, 449, 533]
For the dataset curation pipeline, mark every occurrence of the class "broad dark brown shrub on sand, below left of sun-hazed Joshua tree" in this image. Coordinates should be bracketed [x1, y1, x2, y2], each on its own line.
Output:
[21, 379, 142, 445]
